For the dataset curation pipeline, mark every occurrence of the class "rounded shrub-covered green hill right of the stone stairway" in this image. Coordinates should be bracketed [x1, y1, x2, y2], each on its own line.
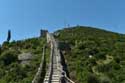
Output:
[54, 26, 125, 83]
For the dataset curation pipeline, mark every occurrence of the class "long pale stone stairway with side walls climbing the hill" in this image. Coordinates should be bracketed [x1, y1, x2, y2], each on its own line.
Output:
[32, 33, 74, 83]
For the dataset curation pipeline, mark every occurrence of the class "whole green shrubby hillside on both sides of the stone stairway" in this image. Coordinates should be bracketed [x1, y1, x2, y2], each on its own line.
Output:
[0, 26, 125, 83]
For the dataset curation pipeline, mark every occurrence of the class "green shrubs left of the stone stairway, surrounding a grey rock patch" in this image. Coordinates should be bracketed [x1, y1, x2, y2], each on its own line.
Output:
[0, 37, 46, 83]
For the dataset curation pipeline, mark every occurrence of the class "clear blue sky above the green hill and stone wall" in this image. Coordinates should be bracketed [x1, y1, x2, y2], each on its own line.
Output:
[0, 0, 125, 43]
